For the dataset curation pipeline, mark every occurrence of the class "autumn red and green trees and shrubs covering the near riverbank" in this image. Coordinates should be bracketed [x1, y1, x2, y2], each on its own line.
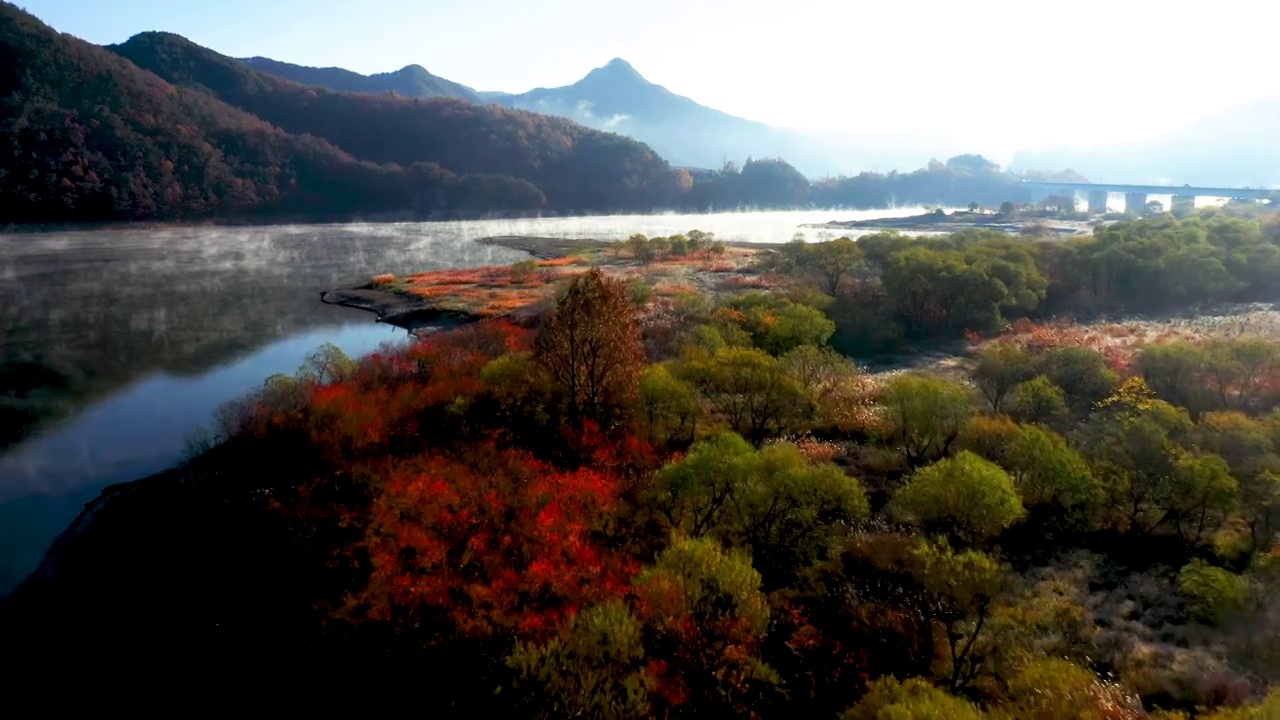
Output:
[0, 210, 1280, 720]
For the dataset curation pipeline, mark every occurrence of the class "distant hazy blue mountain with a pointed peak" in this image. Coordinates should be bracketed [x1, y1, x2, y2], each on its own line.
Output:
[481, 59, 849, 177]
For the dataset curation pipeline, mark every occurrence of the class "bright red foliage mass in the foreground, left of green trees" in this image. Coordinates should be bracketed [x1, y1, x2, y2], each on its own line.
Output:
[349, 445, 635, 642]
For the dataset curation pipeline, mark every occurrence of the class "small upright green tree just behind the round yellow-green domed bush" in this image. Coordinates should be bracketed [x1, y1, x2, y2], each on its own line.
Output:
[881, 373, 970, 468]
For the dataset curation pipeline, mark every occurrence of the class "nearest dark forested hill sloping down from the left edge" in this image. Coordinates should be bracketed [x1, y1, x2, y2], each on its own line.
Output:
[0, 3, 457, 223]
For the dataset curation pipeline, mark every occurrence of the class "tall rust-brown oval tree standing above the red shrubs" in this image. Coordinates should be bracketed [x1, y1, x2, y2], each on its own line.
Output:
[534, 269, 644, 427]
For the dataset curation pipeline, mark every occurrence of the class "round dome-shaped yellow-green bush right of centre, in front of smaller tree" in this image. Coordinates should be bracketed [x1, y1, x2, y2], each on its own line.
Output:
[893, 451, 1027, 544]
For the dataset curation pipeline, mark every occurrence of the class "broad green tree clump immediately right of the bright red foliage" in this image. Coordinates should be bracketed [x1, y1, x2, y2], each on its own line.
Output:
[658, 433, 868, 588]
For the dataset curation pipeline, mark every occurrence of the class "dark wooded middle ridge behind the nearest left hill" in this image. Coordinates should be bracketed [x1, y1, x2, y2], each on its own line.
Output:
[109, 32, 677, 210]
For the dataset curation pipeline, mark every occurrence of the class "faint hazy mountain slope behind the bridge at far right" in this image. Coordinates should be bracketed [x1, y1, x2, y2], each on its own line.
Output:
[1012, 99, 1280, 187]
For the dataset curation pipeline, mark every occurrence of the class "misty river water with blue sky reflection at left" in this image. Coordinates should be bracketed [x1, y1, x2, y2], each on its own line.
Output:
[0, 208, 919, 589]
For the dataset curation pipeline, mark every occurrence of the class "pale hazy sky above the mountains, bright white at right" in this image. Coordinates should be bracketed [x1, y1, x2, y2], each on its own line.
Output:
[19, 0, 1280, 158]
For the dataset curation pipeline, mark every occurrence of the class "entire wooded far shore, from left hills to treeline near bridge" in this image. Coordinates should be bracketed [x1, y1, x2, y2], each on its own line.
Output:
[0, 1, 1100, 224]
